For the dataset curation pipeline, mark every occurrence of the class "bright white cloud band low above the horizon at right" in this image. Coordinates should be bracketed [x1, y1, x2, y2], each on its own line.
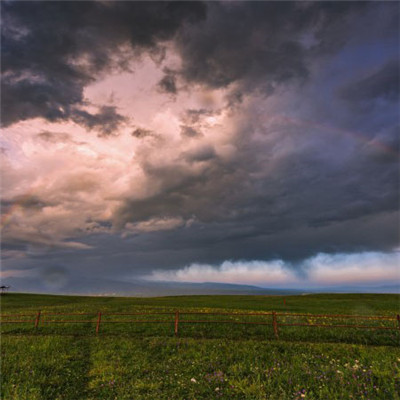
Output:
[144, 253, 400, 288]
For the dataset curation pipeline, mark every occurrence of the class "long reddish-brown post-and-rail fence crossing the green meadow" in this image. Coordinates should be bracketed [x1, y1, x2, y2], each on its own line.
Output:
[0, 310, 400, 339]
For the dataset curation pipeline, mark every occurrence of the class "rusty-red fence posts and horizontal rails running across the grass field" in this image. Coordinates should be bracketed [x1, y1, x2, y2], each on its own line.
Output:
[0, 310, 400, 339]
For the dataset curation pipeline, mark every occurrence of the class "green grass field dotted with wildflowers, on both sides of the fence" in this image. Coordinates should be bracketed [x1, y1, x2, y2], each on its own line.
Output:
[1, 294, 400, 400]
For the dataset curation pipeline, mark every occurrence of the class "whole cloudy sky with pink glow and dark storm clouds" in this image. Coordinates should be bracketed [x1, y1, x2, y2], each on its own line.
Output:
[0, 0, 400, 293]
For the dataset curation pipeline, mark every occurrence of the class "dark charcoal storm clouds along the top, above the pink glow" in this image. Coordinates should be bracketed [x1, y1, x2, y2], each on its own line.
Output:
[2, 1, 376, 129]
